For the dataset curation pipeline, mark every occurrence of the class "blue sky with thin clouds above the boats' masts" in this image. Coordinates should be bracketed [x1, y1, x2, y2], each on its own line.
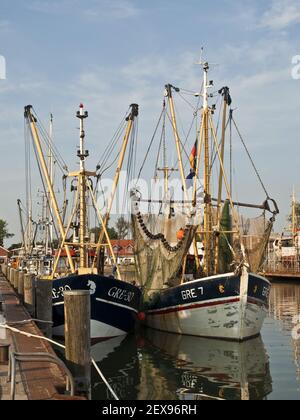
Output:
[0, 0, 300, 244]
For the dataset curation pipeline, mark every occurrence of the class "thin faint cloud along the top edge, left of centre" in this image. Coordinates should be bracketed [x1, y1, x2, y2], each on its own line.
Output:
[27, 0, 140, 20]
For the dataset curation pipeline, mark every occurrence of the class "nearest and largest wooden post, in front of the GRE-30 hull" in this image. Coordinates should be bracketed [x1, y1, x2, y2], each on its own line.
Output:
[65, 290, 91, 396]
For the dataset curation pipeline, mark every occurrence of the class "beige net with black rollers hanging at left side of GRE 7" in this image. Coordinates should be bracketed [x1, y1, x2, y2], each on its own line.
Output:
[132, 194, 197, 294]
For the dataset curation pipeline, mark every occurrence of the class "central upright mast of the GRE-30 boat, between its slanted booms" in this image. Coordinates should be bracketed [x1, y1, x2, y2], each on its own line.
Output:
[77, 104, 89, 268]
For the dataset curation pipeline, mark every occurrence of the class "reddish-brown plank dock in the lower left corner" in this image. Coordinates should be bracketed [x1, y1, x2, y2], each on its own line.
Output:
[0, 274, 78, 400]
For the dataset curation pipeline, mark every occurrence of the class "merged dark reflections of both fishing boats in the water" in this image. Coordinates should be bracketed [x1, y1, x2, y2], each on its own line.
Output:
[93, 330, 272, 400]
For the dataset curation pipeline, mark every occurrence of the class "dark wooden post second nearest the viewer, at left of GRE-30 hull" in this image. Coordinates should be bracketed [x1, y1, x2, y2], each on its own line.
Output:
[35, 279, 52, 338]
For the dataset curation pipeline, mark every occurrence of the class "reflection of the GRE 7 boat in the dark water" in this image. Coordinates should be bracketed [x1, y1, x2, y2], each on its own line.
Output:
[143, 330, 272, 400]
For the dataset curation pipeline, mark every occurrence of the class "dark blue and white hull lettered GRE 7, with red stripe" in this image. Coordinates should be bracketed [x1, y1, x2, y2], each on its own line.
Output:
[146, 273, 271, 341]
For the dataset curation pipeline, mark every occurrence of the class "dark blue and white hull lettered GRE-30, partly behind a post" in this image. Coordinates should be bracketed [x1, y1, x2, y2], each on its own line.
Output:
[52, 275, 141, 340]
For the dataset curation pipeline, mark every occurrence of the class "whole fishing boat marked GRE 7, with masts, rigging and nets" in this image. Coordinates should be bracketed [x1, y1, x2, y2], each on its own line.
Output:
[132, 57, 278, 341]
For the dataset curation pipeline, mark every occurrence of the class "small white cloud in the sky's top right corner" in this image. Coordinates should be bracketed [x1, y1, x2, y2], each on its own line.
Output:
[260, 0, 300, 30]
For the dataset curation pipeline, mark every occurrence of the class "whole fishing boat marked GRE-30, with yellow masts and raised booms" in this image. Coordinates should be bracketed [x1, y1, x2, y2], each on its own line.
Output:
[25, 105, 141, 340]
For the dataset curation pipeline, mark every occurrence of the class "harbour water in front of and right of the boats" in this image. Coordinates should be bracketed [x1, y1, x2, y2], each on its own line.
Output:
[92, 283, 300, 400]
